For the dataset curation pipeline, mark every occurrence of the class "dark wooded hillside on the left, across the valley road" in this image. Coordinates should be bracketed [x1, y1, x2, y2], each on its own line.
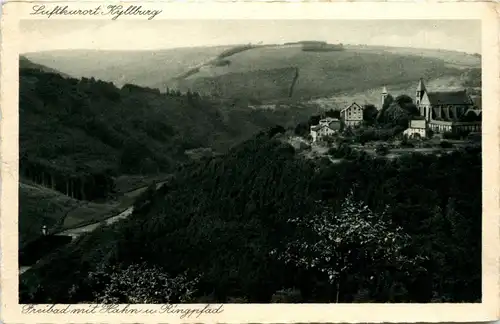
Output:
[19, 58, 316, 199]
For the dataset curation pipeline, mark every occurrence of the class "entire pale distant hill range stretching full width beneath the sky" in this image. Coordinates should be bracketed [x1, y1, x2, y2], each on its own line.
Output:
[22, 43, 480, 101]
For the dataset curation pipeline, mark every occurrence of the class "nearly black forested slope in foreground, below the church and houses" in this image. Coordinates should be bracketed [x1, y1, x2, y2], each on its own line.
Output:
[20, 127, 482, 303]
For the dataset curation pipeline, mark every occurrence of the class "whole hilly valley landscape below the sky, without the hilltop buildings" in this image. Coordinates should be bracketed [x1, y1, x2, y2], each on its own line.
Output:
[19, 41, 482, 303]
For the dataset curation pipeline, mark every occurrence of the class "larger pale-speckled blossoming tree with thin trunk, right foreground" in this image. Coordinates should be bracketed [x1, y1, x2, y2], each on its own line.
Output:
[274, 191, 424, 302]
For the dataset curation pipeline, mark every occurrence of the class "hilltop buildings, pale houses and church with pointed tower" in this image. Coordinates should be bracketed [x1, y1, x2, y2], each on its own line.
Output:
[310, 79, 482, 142]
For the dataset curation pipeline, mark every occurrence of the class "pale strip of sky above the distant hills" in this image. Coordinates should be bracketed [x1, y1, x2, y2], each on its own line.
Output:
[20, 19, 481, 53]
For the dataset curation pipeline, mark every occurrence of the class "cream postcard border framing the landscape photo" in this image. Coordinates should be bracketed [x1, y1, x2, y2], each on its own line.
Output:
[0, 1, 500, 323]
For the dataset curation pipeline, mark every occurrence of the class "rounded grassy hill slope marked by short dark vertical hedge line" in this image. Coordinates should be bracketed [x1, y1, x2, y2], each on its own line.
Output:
[179, 46, 468, 99]
